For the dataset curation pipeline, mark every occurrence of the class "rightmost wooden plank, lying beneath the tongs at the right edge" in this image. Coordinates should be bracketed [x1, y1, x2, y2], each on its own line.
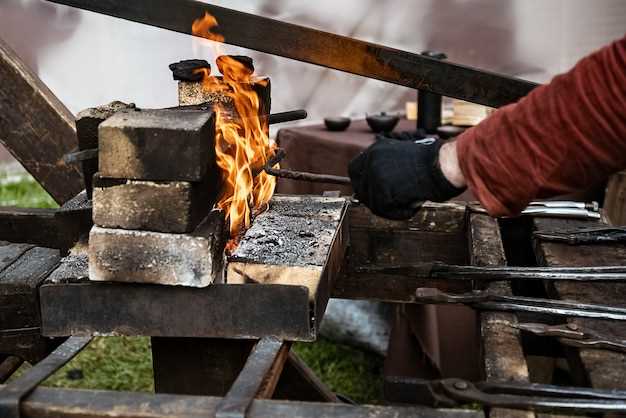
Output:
[535, 218, 626, 389]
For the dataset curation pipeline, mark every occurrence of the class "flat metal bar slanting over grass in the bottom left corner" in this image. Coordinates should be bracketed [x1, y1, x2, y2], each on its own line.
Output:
[0, 337, 91, 418]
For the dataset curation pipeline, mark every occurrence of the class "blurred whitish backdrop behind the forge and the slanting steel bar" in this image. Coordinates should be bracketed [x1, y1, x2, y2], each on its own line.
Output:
[0, 0, 626, 119]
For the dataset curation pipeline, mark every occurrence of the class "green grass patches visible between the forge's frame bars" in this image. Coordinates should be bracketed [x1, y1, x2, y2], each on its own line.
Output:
[0, 171, 383, 403]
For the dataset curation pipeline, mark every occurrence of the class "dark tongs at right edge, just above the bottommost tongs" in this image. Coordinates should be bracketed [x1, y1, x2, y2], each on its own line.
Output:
[511, 323, 626, 353]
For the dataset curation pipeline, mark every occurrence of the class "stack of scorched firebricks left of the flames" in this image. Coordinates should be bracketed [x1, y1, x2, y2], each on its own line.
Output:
[76, 57, 269, 287]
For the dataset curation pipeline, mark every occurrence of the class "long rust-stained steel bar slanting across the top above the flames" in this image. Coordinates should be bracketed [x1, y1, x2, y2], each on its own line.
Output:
[49, 0, 537, 107]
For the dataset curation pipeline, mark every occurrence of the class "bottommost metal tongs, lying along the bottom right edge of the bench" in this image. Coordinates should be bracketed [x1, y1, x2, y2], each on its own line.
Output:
[386, 377, 626, 414]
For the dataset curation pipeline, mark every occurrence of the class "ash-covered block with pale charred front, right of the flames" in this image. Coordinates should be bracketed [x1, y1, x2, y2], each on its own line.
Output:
[226, 196, 347, 327]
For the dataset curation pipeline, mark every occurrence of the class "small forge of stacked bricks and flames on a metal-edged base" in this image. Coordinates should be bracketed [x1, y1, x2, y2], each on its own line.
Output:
[41, 57, 348, 340]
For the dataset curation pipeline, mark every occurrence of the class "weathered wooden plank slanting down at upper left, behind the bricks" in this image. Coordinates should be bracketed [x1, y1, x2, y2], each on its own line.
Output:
[0, 39, 84, 204]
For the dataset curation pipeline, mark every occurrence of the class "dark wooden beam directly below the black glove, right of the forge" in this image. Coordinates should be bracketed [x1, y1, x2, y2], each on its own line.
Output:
[332, 203, 471, 302]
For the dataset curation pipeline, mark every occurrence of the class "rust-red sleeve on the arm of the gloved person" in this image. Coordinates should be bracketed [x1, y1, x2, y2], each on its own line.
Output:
[457, 37, 626, 216]
